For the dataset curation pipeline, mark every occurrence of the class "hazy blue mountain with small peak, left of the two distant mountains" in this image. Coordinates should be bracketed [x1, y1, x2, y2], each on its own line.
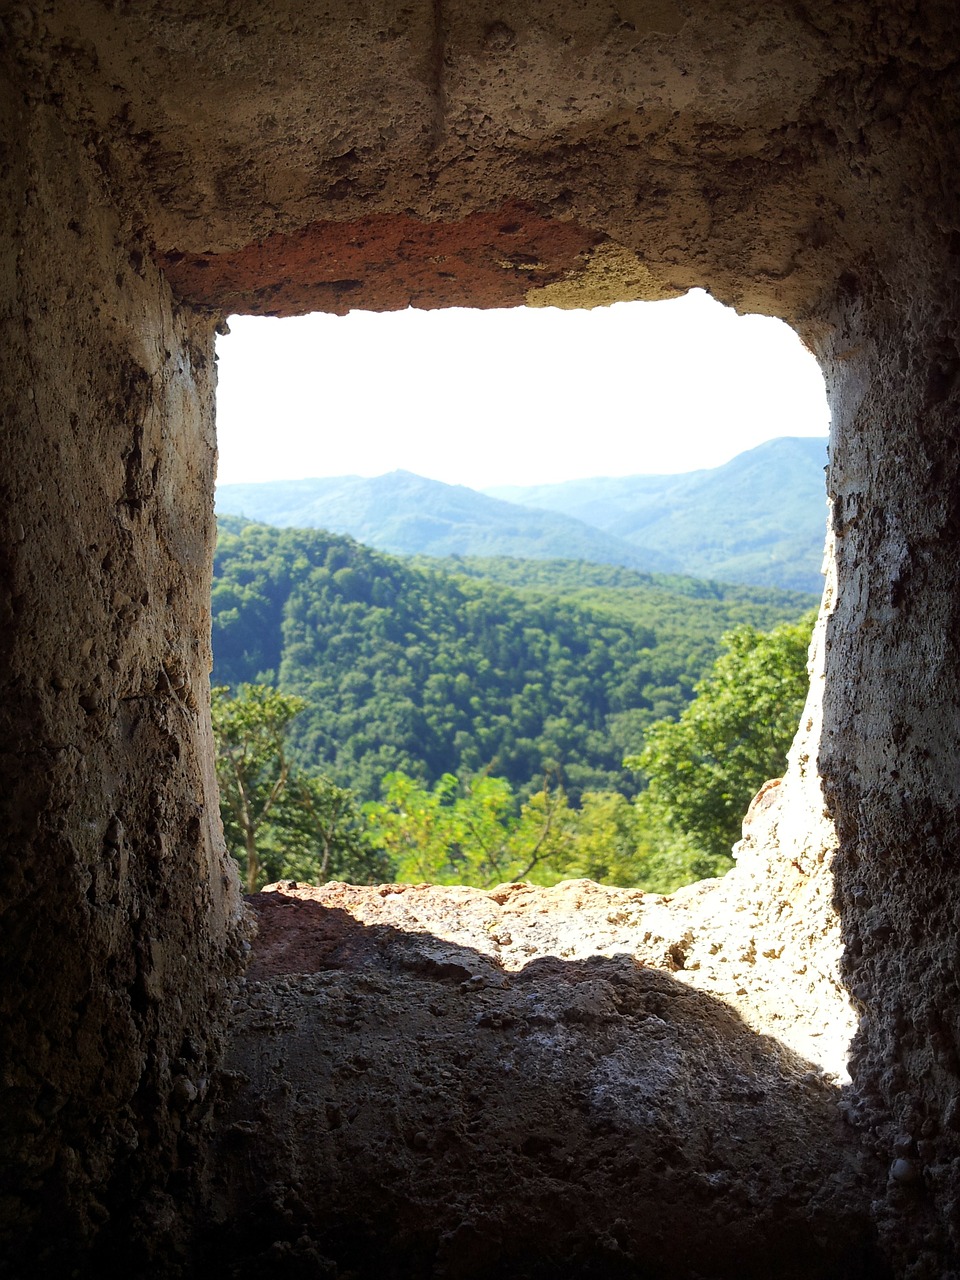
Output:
[216, 471, 680, 571]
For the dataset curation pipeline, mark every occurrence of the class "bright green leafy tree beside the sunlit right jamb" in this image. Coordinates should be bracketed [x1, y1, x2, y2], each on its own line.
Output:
[625, 614, 813, 882]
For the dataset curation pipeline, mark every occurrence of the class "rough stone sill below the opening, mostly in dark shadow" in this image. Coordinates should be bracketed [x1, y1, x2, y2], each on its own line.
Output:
[204, 881, 886, 1280]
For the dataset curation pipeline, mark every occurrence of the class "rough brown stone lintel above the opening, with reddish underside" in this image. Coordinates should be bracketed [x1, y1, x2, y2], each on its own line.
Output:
[28, 0, 901, 316]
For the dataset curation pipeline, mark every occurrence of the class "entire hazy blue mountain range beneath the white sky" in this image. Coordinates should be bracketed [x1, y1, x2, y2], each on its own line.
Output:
[216, 436, 827, 593]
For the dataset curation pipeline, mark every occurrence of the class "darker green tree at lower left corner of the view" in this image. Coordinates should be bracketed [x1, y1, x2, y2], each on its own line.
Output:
[211, 684, 392, 893]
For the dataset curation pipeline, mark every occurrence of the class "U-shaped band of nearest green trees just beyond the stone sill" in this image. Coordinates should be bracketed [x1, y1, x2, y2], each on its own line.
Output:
[214, 606, 813, 892]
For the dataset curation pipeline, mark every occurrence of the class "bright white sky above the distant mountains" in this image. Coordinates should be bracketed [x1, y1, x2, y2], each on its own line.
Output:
[218, 289, 829, 489]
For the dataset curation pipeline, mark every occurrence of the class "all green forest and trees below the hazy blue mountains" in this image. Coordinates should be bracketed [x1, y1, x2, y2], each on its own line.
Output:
[214, 520, 809, 892]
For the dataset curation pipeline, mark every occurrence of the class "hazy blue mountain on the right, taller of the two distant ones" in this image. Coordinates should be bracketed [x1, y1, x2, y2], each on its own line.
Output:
[488, 436, 827, 591]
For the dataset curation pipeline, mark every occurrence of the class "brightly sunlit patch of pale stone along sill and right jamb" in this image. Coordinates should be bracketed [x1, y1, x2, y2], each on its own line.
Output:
[209, 296, 851, 1082]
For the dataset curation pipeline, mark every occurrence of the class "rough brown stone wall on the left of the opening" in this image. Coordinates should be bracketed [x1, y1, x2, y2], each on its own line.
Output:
[0, 35, 248, 1275]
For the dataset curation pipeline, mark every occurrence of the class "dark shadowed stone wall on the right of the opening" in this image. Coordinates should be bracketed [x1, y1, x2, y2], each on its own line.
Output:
[819, 270, 960, 1276]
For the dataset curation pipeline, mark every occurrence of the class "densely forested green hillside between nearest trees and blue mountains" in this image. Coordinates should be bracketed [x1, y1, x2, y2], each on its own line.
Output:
[212, 518, 810, 804]
